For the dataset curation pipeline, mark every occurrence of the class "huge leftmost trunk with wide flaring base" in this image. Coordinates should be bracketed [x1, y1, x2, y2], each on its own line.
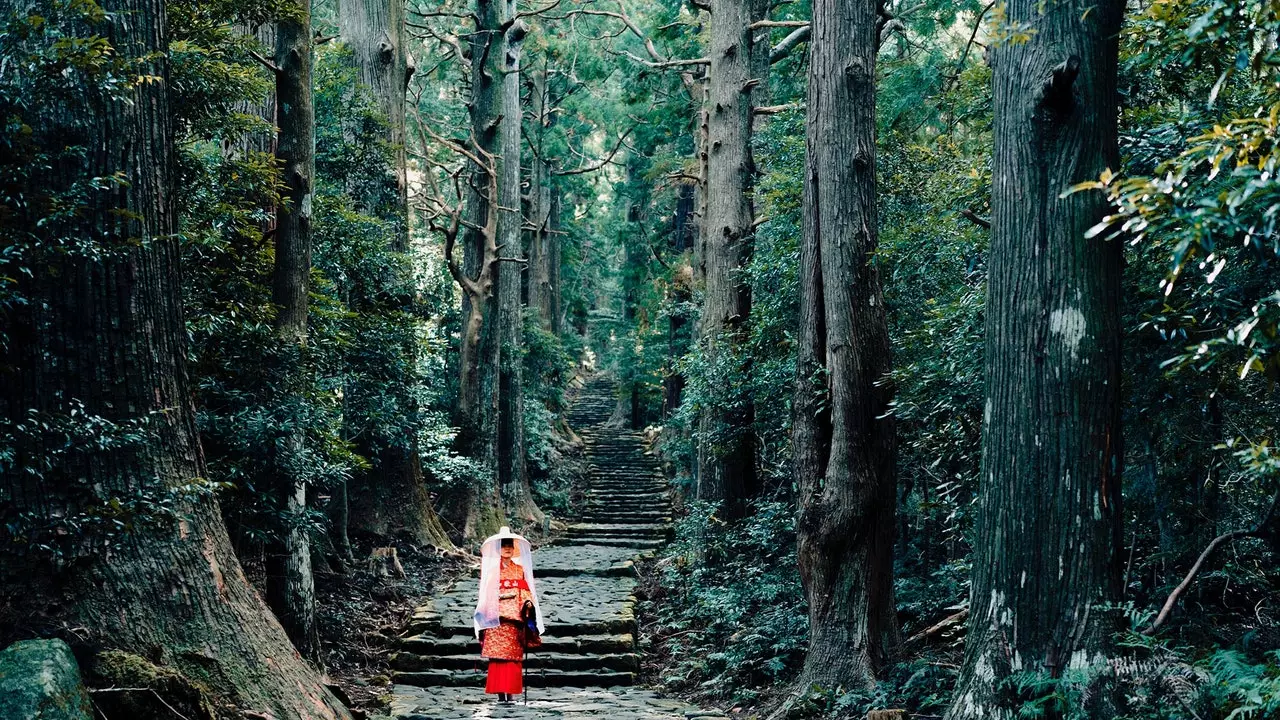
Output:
[0, 0, 349, 720]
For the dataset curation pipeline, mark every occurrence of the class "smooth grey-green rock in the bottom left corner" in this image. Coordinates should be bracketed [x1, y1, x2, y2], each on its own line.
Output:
[0, 639, 93, 720]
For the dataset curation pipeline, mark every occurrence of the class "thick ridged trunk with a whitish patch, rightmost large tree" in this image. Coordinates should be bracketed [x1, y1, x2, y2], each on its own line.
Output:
[947, 0, 1124, 720]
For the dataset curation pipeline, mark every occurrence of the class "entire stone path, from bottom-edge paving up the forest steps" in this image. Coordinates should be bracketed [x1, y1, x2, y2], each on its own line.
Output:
[392, 375, 723, 720]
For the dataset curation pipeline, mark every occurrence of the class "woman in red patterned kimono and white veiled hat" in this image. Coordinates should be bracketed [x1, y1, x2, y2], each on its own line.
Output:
[475, 527, 543, 702]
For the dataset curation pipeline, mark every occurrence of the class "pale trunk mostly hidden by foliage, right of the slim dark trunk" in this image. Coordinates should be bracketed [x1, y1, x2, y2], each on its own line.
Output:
[339, 0, 453, 548]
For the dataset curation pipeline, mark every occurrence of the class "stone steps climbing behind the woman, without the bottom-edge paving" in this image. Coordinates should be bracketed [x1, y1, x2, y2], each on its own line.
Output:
[392, 375, 671, 688]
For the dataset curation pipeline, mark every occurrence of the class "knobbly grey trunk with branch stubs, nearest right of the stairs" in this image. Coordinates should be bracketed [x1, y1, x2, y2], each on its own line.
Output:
[698, 0, 762, 516]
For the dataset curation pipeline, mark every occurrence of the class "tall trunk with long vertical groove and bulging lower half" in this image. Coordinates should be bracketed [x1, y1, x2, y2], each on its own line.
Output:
[792, 0, 901, 688]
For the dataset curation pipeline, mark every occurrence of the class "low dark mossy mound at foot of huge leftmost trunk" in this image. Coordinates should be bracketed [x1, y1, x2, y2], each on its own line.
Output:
[91, 650, 219, 720]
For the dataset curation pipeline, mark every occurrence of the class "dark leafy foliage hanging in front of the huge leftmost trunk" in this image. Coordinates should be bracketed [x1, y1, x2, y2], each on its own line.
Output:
[0, 0, 238, 562]
